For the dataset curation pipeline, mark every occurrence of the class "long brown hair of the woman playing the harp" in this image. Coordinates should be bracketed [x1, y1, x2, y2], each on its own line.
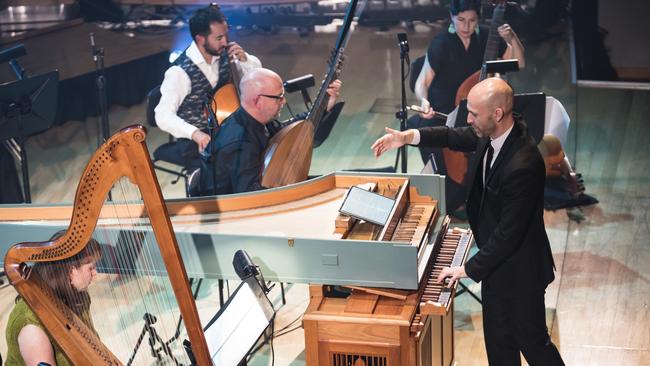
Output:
[32, 230, 101, 315]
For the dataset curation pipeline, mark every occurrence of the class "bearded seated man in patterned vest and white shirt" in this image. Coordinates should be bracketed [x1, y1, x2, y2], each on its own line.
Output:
[155, 4, 262, 172]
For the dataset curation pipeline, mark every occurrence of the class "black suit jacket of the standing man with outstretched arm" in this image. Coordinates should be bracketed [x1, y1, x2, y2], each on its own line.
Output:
[419, 121, 554, 295]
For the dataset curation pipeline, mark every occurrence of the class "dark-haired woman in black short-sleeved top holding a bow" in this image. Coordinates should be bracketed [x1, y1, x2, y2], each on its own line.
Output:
[408, 0, 525, 216]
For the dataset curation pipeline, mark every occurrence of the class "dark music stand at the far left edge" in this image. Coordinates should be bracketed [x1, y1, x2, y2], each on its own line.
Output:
[0, 71, 59, 203]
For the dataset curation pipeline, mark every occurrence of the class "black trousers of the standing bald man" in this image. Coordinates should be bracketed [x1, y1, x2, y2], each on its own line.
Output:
[482, 290, 564, 366]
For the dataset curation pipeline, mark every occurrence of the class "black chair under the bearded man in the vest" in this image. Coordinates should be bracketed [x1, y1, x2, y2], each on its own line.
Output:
[147, 85, 188, 186]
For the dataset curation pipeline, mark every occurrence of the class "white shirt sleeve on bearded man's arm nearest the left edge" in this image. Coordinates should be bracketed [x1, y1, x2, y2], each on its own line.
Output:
[154, 66, 197, 139]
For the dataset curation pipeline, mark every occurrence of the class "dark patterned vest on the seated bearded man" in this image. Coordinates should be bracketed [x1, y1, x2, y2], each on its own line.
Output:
[174, 52, 230, 130]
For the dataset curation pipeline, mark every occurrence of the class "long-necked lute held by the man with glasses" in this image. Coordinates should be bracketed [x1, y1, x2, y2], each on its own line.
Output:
[260, 0, 358, 188]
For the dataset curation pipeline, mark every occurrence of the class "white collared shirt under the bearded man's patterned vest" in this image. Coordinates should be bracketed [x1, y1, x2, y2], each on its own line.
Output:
[155, 42, 262, 139]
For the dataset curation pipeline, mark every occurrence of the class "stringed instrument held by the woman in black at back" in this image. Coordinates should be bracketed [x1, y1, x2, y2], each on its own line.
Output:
[442, 0, 506, 184]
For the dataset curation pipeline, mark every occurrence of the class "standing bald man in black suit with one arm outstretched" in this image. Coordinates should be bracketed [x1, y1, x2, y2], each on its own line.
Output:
[372, 78, 564, 366]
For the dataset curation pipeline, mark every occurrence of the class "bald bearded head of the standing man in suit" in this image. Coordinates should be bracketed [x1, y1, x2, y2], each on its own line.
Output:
[467, 78, 514, 139]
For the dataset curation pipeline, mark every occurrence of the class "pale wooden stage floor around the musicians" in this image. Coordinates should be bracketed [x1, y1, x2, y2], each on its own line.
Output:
[0, 20, 650, 365]
